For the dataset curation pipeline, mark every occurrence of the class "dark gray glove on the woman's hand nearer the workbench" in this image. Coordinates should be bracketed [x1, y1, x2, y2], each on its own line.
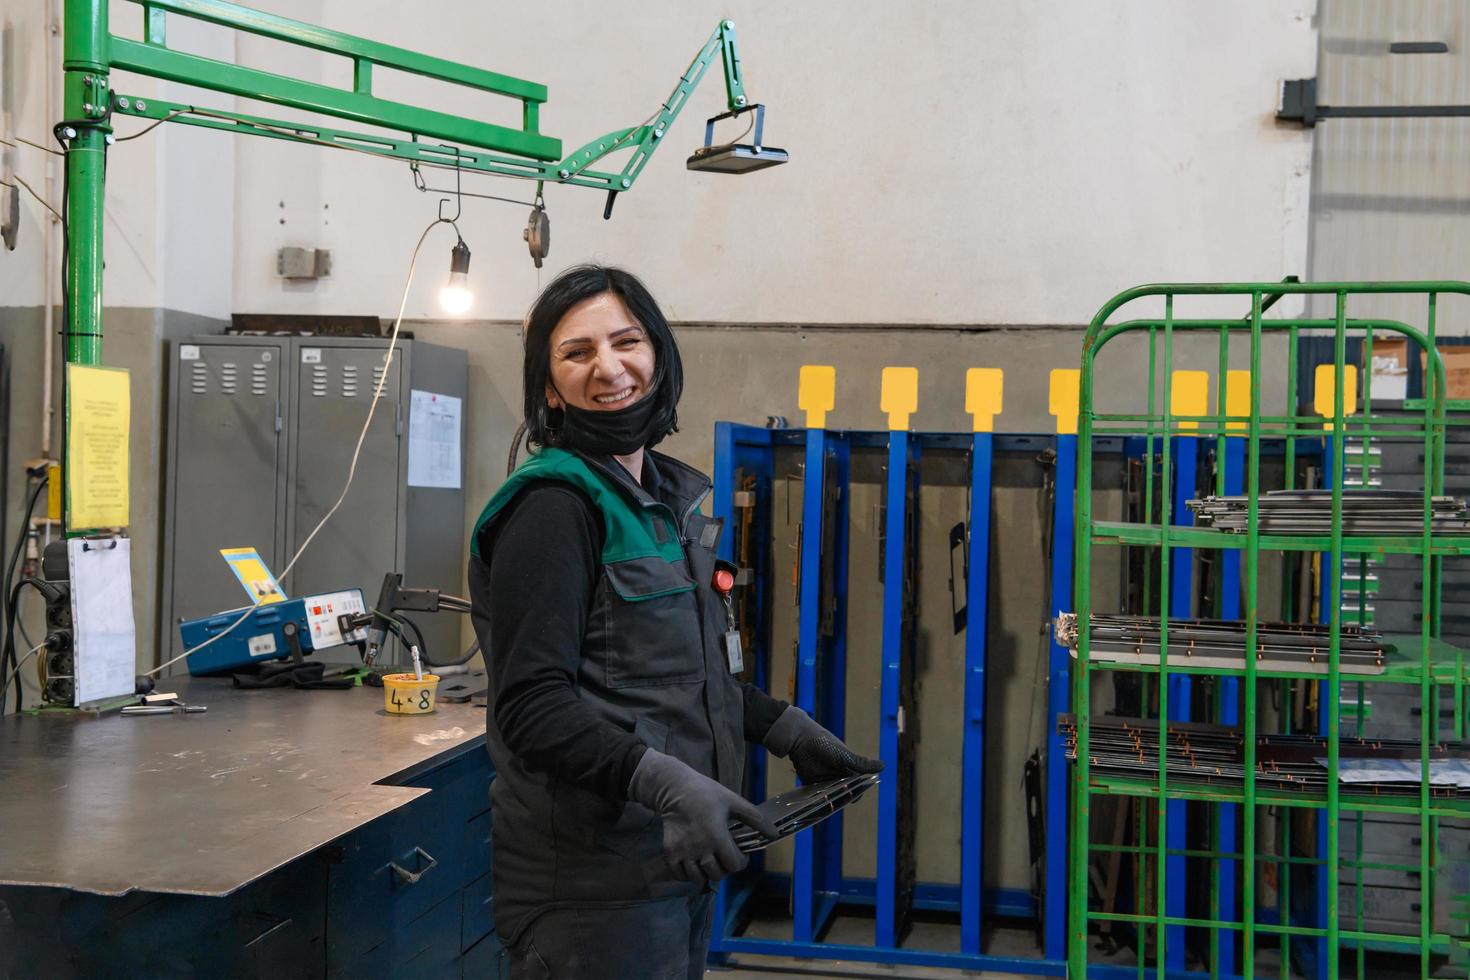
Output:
[628, 749, 781, 887]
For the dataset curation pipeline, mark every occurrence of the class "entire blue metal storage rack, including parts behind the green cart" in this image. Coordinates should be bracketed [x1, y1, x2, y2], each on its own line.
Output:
[710, 422, 1320, 977]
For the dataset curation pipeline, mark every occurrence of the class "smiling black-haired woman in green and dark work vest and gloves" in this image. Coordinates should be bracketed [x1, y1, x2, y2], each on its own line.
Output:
[469, 266, 882, 980]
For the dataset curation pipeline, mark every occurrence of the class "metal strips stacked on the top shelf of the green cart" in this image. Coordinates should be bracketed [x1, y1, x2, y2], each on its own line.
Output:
[1189, 489, 1470, 538]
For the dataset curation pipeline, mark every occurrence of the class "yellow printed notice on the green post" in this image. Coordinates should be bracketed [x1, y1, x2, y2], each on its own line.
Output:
[66, 364, 129, 530]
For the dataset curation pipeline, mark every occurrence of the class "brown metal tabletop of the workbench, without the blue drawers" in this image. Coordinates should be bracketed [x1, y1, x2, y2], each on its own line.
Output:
[0, 679, 485, 895]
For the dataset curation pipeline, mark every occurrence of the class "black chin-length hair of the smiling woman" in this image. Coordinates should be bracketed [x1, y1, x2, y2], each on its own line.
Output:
[506, 264, 684, 473]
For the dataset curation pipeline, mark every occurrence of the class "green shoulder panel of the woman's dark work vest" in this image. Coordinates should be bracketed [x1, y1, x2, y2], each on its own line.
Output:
[469, 447, 684, 564]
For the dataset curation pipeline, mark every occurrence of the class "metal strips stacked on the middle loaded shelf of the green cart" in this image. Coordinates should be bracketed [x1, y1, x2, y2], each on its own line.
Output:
[1054, 613, 1392, 674]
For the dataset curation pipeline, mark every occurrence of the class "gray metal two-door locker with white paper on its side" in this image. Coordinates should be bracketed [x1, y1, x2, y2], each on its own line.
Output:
[160, 336, 469, 663]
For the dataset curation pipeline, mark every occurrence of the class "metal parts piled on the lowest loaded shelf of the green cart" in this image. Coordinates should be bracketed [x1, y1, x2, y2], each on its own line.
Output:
[1057, 714, 1470, 799]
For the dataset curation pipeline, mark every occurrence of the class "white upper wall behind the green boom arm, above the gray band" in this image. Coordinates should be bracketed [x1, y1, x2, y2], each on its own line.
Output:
[223, 0, 1314, 323]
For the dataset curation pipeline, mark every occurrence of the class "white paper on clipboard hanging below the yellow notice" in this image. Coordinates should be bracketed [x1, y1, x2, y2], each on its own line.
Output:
[66, 538, 137, 704]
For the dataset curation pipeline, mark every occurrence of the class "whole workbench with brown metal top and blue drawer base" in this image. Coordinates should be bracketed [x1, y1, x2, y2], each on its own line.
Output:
[0, 679, 500, 977]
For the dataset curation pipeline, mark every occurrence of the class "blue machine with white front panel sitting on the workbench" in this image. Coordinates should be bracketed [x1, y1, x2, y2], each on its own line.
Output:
[179, 589, 368, 677]
